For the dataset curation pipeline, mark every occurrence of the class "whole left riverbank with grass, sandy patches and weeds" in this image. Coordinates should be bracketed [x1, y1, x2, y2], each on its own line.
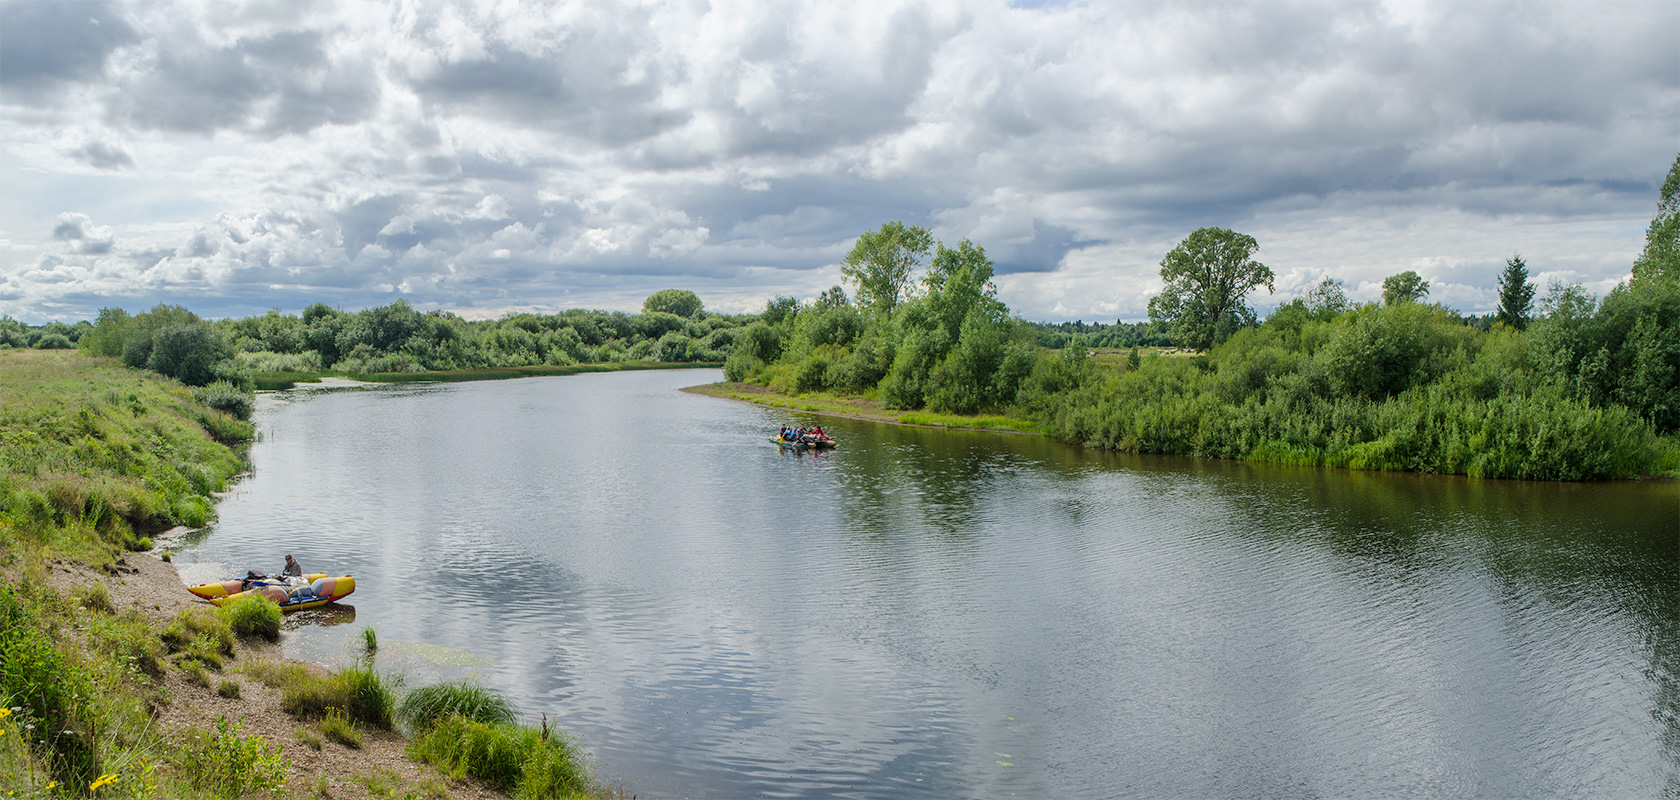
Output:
[0, 350, 608, 798]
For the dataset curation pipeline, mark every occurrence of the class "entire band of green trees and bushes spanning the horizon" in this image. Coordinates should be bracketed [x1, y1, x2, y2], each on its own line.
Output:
[0, 158, 1680, 479]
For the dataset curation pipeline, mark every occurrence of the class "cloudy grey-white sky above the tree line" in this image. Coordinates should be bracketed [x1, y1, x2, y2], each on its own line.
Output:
[0, 0, 1680, 324]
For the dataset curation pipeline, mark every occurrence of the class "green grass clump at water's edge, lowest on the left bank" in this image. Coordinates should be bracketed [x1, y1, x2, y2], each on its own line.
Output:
[408, 716, 593, 800]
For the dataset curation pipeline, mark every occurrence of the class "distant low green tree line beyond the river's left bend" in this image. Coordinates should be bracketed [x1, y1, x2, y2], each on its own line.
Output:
[0, 289, 742, 418]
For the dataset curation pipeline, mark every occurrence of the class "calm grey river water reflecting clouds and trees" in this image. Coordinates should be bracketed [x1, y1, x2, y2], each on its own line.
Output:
[178, 370, 1680, 798]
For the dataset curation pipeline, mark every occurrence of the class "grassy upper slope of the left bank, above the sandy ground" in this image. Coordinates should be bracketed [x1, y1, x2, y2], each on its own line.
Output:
[0, 350, 252, 566]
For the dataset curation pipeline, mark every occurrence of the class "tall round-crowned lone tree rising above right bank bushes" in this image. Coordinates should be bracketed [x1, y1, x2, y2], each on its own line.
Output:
[1149, 229, 1273, 350]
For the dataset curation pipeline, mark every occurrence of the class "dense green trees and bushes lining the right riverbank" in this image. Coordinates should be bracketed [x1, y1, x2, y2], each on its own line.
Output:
[724, 158, 1680, 479]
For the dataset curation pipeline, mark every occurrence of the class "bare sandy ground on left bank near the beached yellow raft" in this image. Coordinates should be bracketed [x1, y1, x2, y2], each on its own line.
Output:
[50, 550, 506, 798]
